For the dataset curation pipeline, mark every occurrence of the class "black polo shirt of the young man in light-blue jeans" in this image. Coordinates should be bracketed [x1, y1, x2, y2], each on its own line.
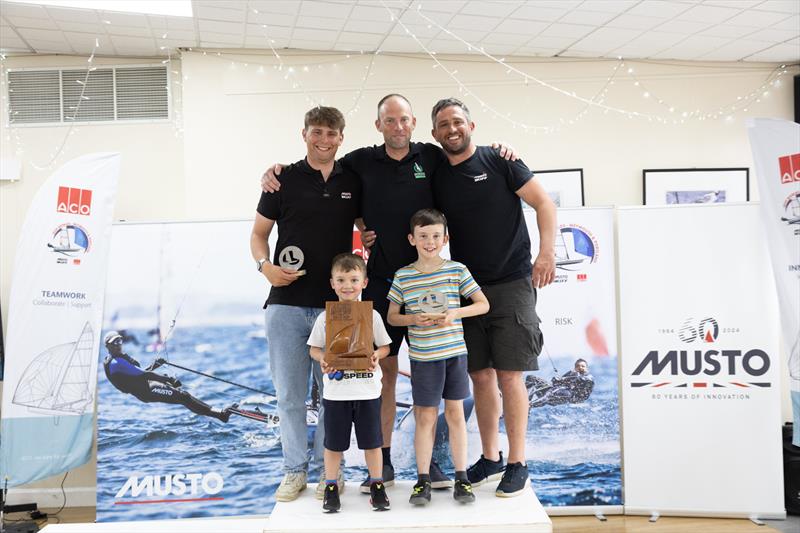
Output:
[256, 159, 361, 307]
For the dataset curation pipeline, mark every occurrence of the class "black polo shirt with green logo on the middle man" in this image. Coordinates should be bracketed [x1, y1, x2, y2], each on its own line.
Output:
[342, 143, 447, 279]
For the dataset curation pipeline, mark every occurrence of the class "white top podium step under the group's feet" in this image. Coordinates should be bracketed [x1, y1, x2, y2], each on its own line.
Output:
[264, 481, 553, 533]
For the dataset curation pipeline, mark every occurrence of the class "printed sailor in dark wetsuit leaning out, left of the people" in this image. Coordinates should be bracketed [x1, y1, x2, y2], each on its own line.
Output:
[103, 331, 236, 422]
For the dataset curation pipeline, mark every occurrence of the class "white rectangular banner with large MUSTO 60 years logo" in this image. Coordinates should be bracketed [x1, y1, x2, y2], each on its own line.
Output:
[617, 204, 785, 518]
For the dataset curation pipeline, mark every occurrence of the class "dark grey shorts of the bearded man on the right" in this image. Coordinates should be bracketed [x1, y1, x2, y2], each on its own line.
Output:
[462, 277, 544, 372]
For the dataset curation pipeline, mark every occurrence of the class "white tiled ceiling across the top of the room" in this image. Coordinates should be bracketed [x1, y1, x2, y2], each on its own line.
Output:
[0, 0, 800, 63]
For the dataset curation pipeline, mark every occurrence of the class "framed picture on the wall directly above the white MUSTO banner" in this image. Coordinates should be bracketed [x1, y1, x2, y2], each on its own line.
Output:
[642, 168, 750, 205]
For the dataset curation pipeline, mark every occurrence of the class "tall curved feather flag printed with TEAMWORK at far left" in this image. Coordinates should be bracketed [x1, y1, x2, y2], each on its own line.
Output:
[0, 153, 120, 487]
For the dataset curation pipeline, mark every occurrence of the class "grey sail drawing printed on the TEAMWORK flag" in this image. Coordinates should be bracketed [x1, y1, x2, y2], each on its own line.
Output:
[11, 322, 94, 414]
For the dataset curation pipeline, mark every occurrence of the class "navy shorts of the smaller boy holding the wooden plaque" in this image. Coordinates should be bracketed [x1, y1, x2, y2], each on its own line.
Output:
[322, 398, 383, 452]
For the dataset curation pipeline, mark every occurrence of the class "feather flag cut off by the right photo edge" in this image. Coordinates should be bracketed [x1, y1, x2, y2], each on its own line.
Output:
[748, 118, 800, 446]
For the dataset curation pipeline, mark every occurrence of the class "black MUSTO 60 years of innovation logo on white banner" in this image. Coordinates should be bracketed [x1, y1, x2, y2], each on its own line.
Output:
[630, 317, 772, 399]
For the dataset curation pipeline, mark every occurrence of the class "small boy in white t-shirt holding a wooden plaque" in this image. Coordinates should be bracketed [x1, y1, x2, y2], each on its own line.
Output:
[308, 254, 392, 513]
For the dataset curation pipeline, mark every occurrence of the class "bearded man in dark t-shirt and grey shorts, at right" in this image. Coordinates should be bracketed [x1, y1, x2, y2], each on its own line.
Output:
[431, 98, 556, 497]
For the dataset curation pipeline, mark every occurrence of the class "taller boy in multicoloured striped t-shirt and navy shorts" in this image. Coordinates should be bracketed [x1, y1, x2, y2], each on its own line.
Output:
[387, 209, 489, 505]
